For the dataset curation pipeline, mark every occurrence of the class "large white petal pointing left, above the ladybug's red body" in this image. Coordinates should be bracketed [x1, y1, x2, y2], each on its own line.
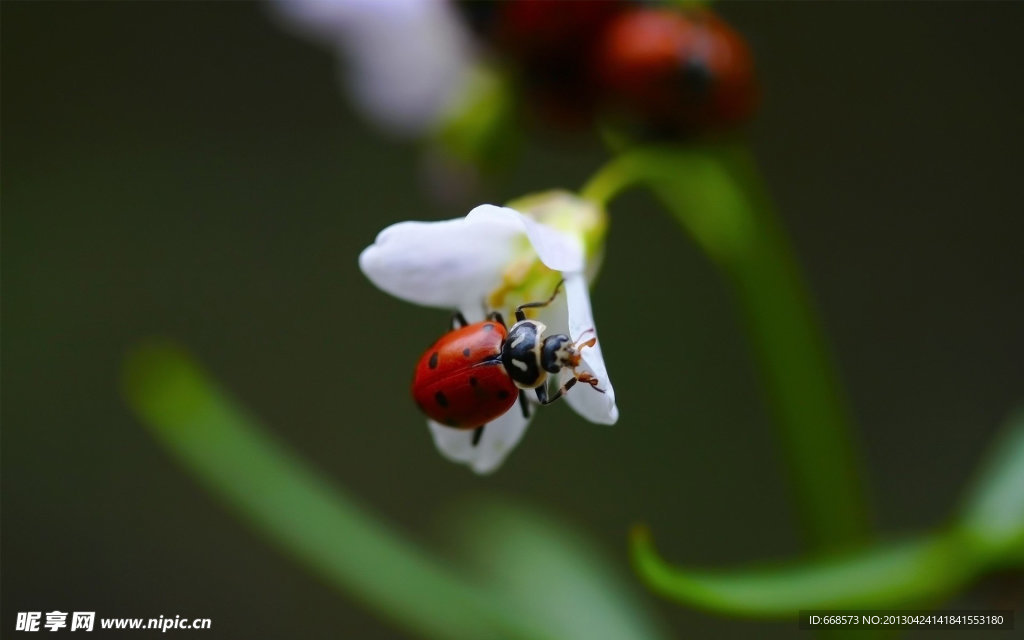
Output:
[359, 217, 522, 309]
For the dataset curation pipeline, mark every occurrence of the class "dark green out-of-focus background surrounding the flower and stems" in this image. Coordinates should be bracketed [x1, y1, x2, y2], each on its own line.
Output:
[0, 2, 1024, 638]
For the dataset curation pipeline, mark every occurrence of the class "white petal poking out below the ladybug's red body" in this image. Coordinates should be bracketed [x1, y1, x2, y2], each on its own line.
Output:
[427, 403, 529, 474]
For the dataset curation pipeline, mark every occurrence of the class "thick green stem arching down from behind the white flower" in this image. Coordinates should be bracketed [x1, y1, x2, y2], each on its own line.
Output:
[582, 146, 867, 549]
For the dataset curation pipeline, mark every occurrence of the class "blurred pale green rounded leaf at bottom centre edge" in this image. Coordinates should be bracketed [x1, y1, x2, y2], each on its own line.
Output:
[454, 501, 669, 640]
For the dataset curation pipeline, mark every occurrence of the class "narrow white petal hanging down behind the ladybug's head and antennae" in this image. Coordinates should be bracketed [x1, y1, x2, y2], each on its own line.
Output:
[564, 273, 618, 424]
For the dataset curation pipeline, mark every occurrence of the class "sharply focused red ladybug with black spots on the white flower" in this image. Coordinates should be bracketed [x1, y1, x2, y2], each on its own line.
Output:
[413, 283, 604, 445]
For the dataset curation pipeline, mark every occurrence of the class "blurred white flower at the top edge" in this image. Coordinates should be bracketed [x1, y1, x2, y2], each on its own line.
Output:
[272, 0, 474, 135]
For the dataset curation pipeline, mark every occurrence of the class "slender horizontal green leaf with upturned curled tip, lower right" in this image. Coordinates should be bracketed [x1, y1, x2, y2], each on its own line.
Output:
[631, 527, 977, 620]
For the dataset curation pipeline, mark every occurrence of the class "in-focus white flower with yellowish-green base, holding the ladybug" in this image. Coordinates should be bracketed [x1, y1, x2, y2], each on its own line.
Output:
[359, 193, 618, 473]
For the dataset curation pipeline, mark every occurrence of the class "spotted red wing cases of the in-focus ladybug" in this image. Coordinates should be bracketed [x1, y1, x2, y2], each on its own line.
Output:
[413, 322, 519, 429]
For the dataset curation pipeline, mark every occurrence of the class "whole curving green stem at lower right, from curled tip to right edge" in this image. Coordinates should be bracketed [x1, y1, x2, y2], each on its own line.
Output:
[630, 411, 1024, 618]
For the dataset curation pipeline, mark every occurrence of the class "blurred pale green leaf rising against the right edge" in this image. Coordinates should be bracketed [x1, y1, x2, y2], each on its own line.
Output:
[958, 410, 1024, 562]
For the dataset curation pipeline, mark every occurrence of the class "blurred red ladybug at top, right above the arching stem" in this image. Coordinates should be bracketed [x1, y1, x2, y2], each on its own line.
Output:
[599, 8, 757, 133]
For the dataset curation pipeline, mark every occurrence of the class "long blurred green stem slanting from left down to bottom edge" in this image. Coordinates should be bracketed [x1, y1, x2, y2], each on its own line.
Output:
[124, 345, 550, 640]
